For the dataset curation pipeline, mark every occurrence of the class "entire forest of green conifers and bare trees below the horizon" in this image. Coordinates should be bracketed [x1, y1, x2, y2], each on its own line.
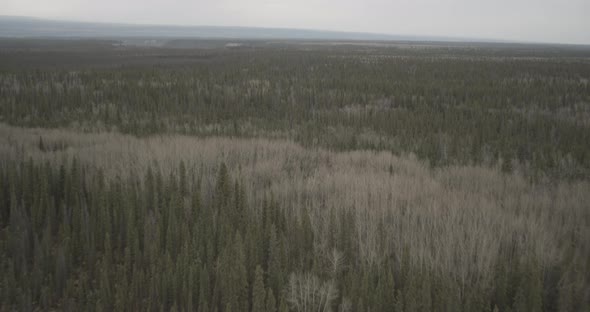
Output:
[0, 39, 590, 312]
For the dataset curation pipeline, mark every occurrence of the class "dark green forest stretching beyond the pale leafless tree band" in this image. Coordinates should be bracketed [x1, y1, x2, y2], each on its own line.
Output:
[0, 45, 590, 179]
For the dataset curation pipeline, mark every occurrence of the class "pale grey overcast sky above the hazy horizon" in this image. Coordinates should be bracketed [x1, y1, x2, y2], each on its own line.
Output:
[0, 0, 590, 44]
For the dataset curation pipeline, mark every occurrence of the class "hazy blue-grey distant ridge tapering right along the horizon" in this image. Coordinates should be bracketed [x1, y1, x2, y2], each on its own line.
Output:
[0, 16, 475, 41]
